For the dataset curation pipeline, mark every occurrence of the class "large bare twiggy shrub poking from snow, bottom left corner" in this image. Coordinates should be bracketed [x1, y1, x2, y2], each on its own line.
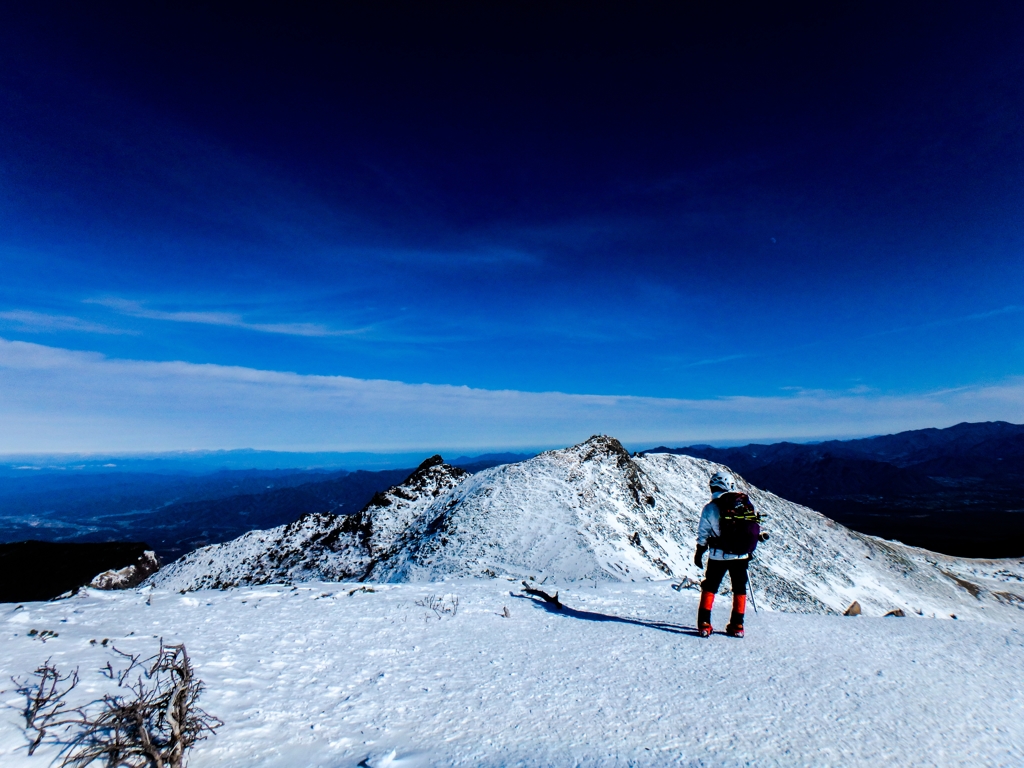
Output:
[15, 641, 223, 768]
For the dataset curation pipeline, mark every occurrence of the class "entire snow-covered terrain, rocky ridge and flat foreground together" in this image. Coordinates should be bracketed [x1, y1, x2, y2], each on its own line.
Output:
[0, 437, 1024, 768]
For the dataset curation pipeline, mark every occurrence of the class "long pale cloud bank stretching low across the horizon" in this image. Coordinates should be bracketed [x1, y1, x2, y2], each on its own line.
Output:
[0, 339, 1024, 453]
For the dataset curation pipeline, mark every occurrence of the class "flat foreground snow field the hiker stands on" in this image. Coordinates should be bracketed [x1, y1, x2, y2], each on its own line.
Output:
[0, 579, 1024, 768]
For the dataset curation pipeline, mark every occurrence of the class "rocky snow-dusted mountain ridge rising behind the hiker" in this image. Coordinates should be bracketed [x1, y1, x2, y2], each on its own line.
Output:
[151, 436, 1024, 622]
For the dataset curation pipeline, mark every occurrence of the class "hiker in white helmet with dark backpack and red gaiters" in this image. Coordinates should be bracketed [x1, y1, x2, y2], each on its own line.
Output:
[693, 472, 768, 637]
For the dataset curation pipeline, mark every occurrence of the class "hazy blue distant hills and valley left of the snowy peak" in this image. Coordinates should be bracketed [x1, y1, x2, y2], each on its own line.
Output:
[0, 454, 528, 568]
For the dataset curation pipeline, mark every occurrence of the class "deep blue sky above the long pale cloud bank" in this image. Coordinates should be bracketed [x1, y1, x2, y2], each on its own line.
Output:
[0, 2, 1024, 450]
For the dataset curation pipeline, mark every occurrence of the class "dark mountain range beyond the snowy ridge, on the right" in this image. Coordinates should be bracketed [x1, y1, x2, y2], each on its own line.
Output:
[645, 422, 1024, 557]
